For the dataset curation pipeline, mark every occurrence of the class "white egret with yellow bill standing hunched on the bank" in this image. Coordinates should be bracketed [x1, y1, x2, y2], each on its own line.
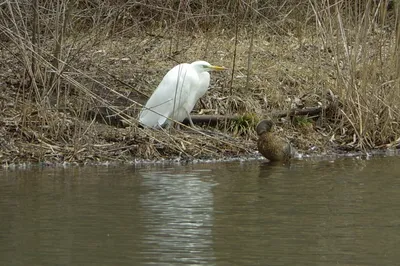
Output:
[139, 61, 225, 128]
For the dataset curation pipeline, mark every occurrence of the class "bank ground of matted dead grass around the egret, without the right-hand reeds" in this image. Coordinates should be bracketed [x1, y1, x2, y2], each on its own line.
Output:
[0, 20, 399, 165]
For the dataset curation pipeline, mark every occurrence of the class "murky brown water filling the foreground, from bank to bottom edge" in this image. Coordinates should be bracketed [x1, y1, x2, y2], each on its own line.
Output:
[0, 157, 400, 265]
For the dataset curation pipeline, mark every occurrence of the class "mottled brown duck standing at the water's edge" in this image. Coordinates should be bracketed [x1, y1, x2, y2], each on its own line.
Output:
[256, 120, 295, 161]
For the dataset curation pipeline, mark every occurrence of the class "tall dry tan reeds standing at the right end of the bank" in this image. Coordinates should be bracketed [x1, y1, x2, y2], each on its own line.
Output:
[315, 1, 400, 149]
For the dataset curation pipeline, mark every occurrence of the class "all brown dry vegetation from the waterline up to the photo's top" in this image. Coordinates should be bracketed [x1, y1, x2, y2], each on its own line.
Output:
[0, 0, 400, 164]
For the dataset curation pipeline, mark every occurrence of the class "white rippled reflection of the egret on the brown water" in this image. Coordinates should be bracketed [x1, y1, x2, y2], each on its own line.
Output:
[140, 171, 215, 265]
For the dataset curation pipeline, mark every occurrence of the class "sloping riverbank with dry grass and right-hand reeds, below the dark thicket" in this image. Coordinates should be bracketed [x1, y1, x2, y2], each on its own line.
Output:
[0, 1, 400, 165]
